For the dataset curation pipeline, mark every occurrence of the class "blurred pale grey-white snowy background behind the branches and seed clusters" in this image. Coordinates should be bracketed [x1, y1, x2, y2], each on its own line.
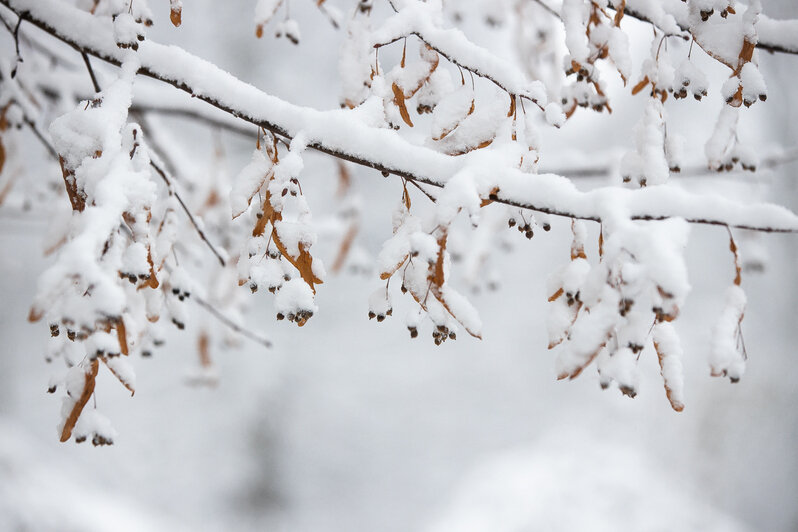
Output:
[0, 0, 798, 532]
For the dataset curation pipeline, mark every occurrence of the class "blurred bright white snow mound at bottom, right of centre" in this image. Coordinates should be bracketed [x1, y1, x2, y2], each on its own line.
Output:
[425, 431, 753, 532]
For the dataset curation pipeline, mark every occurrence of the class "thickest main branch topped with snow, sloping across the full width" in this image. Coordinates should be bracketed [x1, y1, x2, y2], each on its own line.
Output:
[0, 0, 798, 232]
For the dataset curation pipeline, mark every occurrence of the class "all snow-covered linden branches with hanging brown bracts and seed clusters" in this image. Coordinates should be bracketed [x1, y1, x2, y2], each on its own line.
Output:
[0, 0, 798, 445]
